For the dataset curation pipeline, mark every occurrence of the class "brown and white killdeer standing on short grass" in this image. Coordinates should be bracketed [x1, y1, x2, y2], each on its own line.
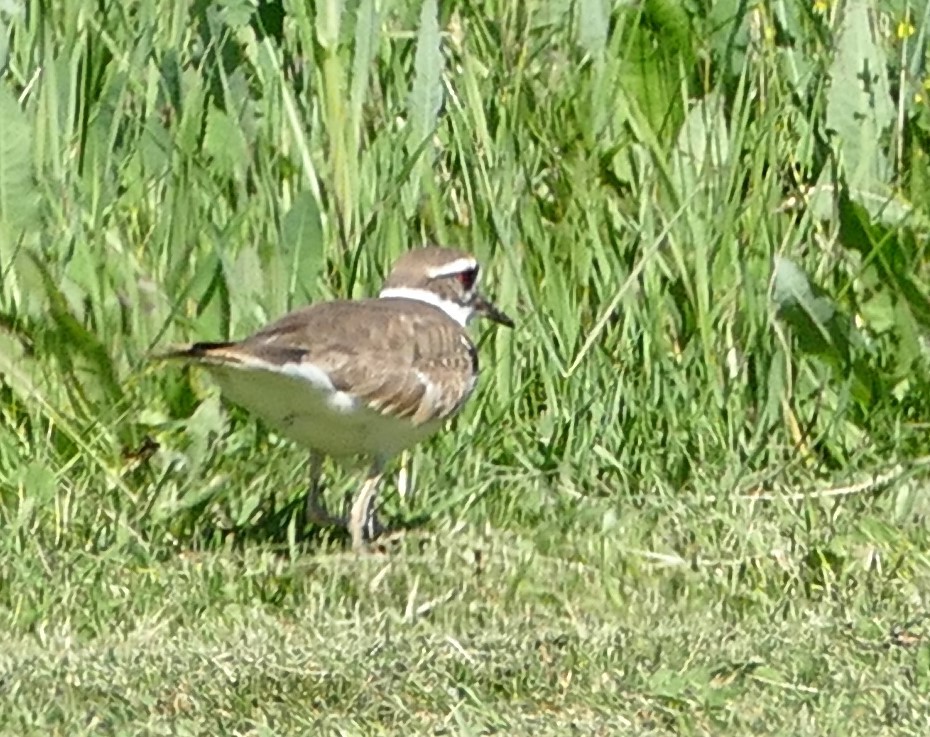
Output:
[163, 246, 513, 549]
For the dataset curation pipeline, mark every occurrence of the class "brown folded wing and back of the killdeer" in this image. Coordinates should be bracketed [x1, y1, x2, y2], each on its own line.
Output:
[236, 299, 478, 424]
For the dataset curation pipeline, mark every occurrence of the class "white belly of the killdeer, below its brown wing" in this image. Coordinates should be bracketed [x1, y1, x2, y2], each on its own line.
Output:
[206, 365, 442, 458]
